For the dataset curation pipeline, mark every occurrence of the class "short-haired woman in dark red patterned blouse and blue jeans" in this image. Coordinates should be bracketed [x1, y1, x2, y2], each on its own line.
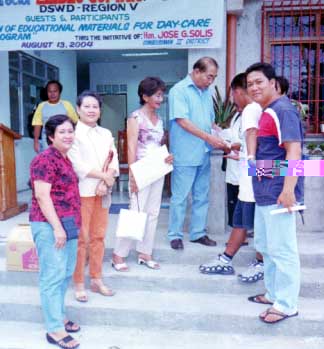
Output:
[30, 115, 80, 349]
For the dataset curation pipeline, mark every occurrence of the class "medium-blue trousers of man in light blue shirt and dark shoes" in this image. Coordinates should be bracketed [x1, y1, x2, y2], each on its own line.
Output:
[168, 153, 210, 241]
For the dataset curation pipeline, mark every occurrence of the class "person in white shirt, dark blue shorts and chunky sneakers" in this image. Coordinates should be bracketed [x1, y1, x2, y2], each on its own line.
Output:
[199, 73, 263, 283]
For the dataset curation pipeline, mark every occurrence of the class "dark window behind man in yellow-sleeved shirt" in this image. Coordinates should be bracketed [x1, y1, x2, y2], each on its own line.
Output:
[9, 51, 59, 136]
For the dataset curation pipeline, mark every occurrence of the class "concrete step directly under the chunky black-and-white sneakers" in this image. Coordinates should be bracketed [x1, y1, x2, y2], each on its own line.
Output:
[0, 258, 324, 299]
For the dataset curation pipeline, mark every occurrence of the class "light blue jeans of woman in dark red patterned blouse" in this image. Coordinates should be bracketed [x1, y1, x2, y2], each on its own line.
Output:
[31, 222, 78, 332]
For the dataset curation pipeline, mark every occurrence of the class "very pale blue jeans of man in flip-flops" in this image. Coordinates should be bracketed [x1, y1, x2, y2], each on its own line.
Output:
[254, 205, 300, 315]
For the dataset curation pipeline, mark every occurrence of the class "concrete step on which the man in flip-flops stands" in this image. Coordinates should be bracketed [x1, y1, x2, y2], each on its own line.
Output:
[0, 286, 324, 337]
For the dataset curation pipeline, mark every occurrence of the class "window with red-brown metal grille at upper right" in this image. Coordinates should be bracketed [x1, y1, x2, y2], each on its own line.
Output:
[262, 0, 324, 134]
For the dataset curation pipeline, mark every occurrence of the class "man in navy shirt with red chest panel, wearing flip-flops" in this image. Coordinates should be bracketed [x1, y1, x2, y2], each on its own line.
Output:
[246, 63, 303, 324]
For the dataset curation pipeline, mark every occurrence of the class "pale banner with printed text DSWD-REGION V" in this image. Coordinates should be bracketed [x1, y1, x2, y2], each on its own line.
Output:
[0, 0, 225, 50]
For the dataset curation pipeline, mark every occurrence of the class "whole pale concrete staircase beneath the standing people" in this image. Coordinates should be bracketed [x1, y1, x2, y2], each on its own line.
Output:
[0, 209, 324, 349]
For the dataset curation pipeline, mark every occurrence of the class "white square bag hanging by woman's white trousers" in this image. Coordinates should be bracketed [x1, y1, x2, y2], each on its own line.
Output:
[116, 193, 147, 241]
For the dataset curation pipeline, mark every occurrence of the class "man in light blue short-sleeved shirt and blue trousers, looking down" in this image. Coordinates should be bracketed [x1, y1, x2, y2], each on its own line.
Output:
[168, 57, 226, 250]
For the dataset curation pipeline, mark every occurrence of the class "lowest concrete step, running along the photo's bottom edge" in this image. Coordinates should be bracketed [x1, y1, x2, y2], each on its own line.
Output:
[0, 321, 324, 349]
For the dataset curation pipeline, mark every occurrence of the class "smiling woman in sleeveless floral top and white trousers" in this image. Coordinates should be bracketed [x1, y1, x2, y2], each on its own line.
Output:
[112, 77, 173, 271]
